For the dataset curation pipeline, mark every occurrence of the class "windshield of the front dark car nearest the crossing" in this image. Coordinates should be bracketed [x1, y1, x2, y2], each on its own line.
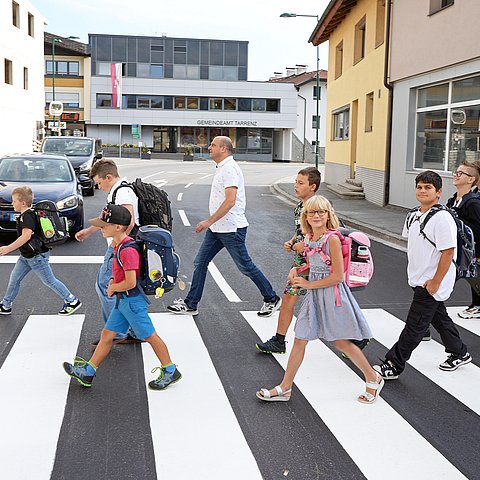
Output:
[0, 158, 73, 183]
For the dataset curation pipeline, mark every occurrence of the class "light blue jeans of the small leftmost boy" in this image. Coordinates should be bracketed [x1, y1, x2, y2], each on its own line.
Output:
[3, 252, 75, 308]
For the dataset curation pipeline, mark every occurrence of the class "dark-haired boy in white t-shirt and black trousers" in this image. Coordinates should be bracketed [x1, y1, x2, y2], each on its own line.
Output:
[373, 170, 472, 380]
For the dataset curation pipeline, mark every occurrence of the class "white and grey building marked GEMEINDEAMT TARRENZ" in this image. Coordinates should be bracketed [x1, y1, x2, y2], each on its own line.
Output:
[87, 34, 297, 162]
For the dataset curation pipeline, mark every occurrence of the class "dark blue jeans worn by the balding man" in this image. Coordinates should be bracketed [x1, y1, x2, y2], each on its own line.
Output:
[185, 227, 276, 309]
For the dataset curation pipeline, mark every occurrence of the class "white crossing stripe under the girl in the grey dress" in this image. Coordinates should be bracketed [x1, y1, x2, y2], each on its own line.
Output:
[241, 312, 470, 480]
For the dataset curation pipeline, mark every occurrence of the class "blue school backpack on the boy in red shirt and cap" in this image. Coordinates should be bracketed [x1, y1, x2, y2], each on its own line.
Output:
[115, 225, 180, 297]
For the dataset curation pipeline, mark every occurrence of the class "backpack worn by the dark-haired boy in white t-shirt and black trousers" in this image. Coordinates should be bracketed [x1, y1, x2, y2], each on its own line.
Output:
[407, 203, 477, 280]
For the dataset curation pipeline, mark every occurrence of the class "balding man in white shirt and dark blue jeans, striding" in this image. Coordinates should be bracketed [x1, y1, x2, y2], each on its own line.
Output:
[167, 137, 282, 317]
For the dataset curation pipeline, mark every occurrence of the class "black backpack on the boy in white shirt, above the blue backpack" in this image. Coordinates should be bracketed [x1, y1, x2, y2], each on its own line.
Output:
[112, 178, 172, 232]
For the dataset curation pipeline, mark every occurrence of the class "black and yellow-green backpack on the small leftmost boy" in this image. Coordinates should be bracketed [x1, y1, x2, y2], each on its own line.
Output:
[32, 200, 70, 247]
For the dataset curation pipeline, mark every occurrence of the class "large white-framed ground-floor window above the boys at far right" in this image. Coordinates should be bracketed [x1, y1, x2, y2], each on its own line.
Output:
[414, 76, 480, 171]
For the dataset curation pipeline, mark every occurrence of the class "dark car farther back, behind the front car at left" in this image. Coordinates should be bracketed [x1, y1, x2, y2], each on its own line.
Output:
[41, 137, 103, 196]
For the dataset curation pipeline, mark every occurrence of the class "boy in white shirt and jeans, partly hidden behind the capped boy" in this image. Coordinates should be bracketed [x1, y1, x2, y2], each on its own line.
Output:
[75, 159, 139, 346]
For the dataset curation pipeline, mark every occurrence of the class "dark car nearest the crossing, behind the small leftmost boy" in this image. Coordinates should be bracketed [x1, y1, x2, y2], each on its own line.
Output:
[0, 153, 84, 237]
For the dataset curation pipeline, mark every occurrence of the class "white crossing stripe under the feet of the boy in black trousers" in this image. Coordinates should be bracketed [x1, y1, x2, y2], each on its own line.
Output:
[363, 308, 480, 415]
